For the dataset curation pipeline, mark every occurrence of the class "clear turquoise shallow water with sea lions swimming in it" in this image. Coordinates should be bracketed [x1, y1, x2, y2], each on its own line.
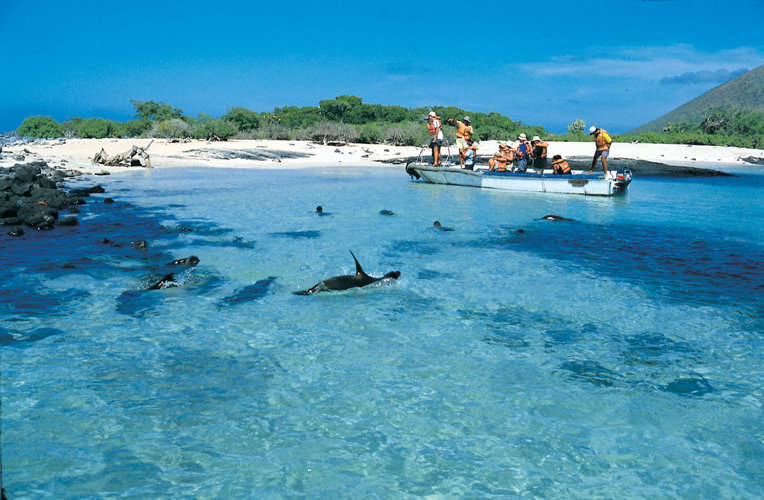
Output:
[0, 167, 764, 499]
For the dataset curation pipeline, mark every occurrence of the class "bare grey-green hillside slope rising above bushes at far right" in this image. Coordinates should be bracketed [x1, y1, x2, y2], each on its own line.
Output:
[624, 65, 764, 135]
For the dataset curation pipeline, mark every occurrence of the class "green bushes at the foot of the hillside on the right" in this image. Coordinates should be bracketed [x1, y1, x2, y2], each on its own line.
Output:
[613, 108, 764, 149]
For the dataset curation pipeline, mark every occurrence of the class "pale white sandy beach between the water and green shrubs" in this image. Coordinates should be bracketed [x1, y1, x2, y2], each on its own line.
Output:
[0, 139, 764, 174]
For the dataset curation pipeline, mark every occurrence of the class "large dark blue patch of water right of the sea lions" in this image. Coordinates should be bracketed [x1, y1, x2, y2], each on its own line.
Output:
[472, 222, 764, 309]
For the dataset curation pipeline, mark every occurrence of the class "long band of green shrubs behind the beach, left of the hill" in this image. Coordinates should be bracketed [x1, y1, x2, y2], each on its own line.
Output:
[17, 95, 547, 146]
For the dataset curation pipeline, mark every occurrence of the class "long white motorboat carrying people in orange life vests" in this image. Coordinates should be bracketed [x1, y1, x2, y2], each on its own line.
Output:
[406, 162, 631, 196]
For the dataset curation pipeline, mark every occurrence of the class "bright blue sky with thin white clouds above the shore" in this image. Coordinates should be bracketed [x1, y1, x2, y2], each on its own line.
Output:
[0, 0, 764, 133]
